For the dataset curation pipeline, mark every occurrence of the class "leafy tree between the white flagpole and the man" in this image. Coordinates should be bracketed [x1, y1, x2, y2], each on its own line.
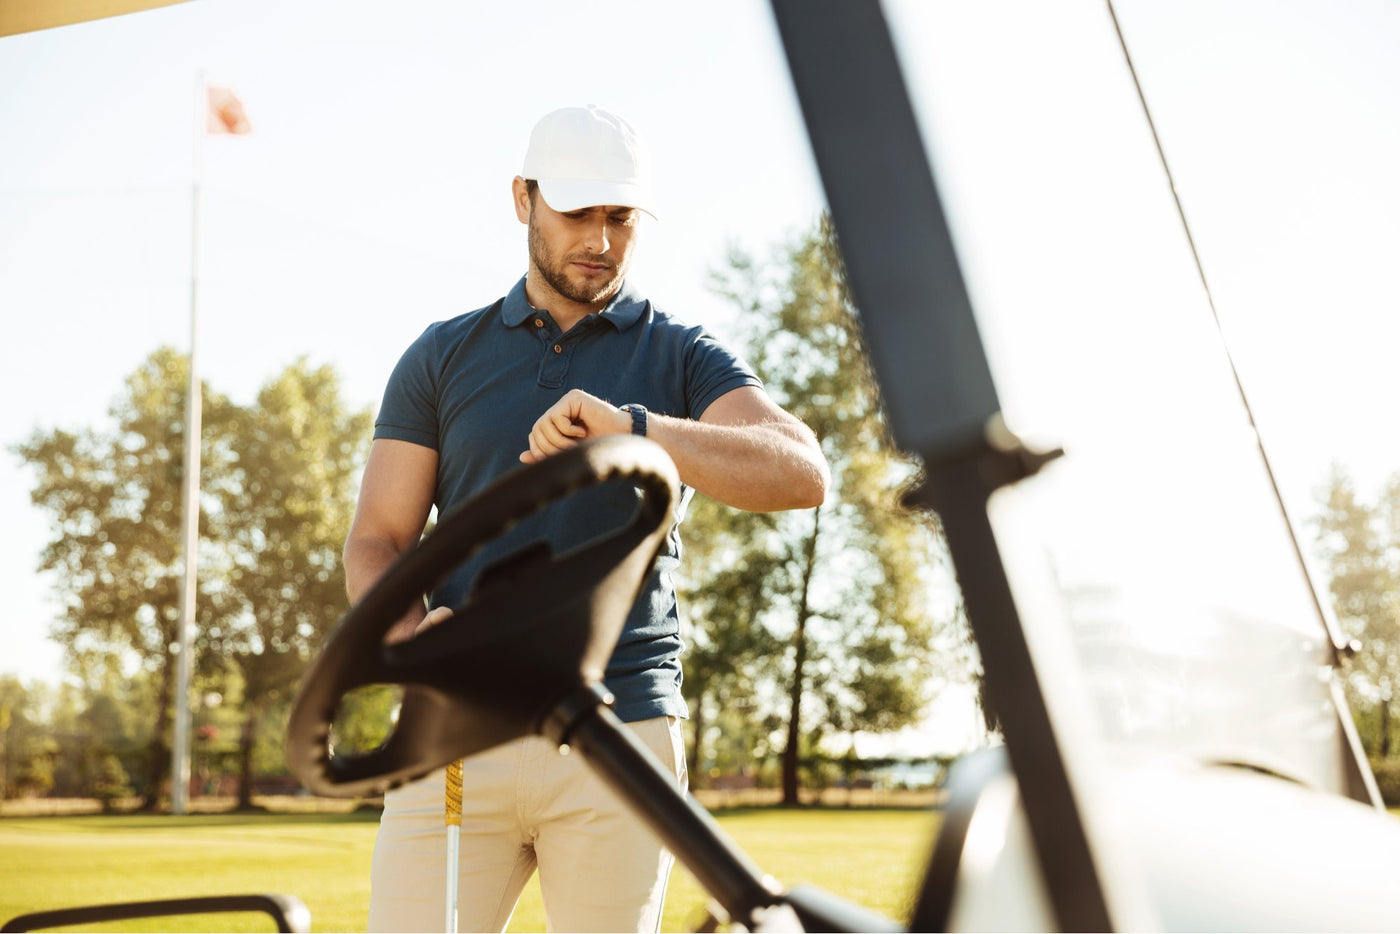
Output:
[210, 360, 372, 808]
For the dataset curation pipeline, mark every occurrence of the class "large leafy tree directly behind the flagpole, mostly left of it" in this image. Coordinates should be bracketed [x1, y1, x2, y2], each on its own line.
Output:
[17, 347, 232, 808]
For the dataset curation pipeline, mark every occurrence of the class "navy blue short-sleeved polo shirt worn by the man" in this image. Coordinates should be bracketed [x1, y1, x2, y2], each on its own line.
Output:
[374, 279, 762, 721]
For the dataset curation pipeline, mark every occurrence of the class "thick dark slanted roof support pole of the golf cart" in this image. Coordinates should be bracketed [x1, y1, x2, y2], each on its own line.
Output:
[771, 0, 1134, 931]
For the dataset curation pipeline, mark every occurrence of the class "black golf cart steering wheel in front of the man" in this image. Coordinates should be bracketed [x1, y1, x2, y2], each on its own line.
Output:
[287, 435, 680, 797]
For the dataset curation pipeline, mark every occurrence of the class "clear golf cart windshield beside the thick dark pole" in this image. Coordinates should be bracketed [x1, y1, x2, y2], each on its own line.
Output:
[886, 3, 1345, 790]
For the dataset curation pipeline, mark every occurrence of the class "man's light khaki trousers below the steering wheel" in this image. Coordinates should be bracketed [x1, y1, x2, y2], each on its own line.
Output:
[368, 717, 689, 931]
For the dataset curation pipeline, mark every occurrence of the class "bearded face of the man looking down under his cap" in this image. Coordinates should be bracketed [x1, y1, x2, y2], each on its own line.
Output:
[529, 192, 640, 311]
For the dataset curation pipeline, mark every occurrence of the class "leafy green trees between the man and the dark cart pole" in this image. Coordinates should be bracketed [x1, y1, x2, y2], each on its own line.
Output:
[685, 218, 966, 804]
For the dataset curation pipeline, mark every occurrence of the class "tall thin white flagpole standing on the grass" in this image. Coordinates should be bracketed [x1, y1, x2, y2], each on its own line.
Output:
[171, 71, 209, 814]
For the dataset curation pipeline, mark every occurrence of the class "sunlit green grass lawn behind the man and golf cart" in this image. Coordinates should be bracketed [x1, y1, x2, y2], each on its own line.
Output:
[0, 808, 938, 931]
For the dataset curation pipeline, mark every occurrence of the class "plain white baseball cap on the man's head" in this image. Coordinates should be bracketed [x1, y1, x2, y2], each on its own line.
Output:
[521, 104, 657, 217]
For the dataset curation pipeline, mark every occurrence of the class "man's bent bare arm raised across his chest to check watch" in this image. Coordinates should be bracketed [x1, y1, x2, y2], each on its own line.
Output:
[521, 386, 830, 513]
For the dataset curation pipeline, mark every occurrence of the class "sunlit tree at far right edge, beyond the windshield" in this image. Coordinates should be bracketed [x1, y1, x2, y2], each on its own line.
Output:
[1316, 468, 1400, 760]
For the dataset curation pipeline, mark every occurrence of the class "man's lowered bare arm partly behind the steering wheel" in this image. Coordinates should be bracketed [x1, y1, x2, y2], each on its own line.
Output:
[343, 438, 438, 643]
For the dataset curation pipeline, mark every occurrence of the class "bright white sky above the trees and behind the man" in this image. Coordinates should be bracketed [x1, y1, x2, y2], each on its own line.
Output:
[0, 0, 1400, 756]
